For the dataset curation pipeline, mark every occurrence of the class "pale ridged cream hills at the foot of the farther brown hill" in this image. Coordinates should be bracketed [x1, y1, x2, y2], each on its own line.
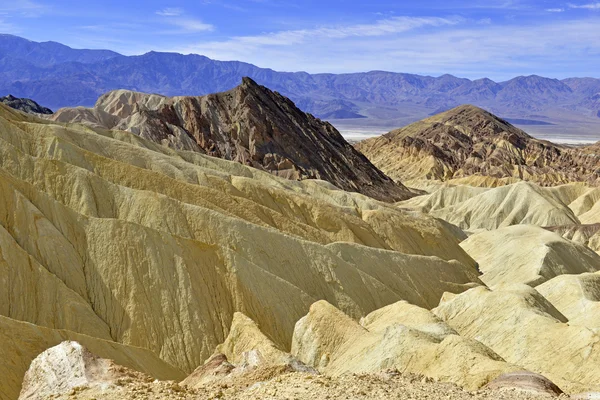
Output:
[397, 181, 600, 247]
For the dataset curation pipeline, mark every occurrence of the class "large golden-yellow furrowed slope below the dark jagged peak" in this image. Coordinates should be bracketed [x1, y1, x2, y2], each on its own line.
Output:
[0, 102, 480, 398]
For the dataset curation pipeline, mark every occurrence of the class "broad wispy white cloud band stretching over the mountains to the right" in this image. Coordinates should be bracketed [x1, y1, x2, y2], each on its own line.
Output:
[165, 17, 600, 78]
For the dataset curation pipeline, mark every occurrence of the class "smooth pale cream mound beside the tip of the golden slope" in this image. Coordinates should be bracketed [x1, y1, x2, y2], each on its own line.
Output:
[460, 225, 600, 288]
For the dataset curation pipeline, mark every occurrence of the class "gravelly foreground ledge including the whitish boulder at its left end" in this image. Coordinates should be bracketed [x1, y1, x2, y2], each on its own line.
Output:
[16, 342, 560, 400]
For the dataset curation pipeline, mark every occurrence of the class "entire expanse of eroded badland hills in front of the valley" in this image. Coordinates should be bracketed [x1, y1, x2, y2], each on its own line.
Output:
[0, 76, 600, 400]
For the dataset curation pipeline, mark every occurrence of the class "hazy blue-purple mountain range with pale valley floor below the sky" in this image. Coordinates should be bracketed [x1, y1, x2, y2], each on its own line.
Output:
[0, 35, 600, 133]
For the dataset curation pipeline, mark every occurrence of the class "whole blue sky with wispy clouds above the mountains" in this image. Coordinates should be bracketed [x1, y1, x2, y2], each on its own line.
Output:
[0, 0, 600, 80]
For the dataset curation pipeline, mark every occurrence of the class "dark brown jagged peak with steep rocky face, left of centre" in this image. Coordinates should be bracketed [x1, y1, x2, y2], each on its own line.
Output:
[51, 78, 412, 201]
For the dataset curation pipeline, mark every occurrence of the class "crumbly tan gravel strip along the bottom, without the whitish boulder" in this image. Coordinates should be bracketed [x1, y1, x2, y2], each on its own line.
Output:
[15, 344, 564, 400]
